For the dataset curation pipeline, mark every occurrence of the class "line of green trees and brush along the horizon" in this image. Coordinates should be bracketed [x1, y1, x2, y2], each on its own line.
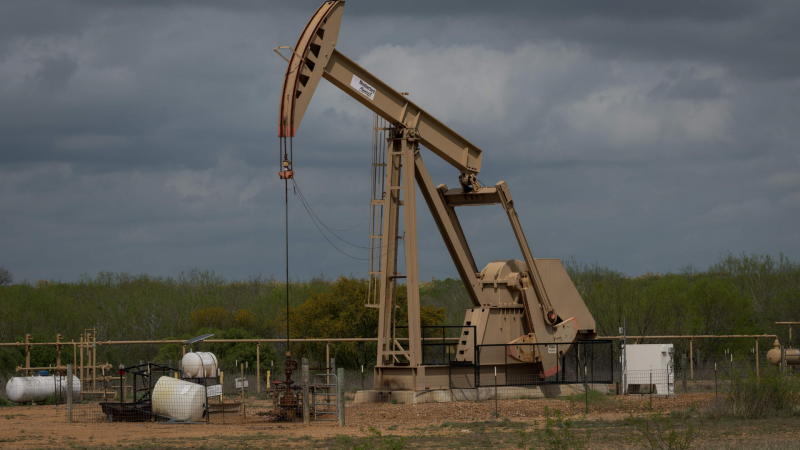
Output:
[0, 254, 800, 375]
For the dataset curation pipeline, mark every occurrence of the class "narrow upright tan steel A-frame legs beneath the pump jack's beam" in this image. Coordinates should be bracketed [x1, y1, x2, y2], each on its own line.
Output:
[376, 128, 422, 372]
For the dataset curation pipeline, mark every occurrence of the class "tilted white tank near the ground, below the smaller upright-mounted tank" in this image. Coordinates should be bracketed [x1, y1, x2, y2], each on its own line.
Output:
[152, 376, 206, 422]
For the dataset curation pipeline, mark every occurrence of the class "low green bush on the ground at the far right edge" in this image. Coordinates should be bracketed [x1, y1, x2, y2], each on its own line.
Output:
[713, 367, 800, 419]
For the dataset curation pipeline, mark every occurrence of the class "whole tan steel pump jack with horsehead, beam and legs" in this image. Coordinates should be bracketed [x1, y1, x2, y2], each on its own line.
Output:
[275, 1, 597, 389]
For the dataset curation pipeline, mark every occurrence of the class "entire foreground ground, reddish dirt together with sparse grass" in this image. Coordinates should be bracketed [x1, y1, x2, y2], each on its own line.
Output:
[0, 394, 800, 449]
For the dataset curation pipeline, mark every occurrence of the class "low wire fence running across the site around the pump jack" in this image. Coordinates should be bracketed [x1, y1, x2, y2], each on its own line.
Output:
[0, 342, 794, 423]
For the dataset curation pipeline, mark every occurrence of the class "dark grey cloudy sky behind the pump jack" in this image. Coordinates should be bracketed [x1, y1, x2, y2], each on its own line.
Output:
[0, 0, 800, 281]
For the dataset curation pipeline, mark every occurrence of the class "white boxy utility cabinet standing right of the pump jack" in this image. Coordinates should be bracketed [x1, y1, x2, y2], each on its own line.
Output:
[625, 344, 675, 395]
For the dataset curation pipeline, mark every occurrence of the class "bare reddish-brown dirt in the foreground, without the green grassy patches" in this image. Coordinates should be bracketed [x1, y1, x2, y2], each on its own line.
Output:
[0, 394, 797, 448]
